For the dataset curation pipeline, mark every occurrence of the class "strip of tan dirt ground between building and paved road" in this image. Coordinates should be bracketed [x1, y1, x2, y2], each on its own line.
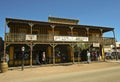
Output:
[0, 62, 120, 82]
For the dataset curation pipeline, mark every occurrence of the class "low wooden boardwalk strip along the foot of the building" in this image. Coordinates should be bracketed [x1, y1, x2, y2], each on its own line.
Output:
[8, 60, 120, 70]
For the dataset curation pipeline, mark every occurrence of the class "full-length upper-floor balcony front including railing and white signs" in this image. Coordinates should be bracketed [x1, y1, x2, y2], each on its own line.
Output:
[6, 33, 115, 44]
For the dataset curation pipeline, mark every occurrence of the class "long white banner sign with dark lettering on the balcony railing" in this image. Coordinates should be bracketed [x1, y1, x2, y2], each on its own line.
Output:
[54, 36, 88, 41]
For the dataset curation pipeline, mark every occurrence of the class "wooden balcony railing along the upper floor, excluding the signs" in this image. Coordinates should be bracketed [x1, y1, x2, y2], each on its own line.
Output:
[6, 33, 115, 44]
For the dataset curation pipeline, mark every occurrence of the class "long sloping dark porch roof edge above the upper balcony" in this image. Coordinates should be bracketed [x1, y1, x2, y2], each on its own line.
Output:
[6, 18, 114, 32]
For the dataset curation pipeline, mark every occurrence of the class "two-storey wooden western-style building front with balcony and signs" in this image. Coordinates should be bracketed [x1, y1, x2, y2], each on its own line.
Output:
[4, 17, 115, 66]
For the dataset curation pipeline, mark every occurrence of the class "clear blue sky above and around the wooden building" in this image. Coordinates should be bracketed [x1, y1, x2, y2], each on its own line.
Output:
[0, 0, 120, 41]
